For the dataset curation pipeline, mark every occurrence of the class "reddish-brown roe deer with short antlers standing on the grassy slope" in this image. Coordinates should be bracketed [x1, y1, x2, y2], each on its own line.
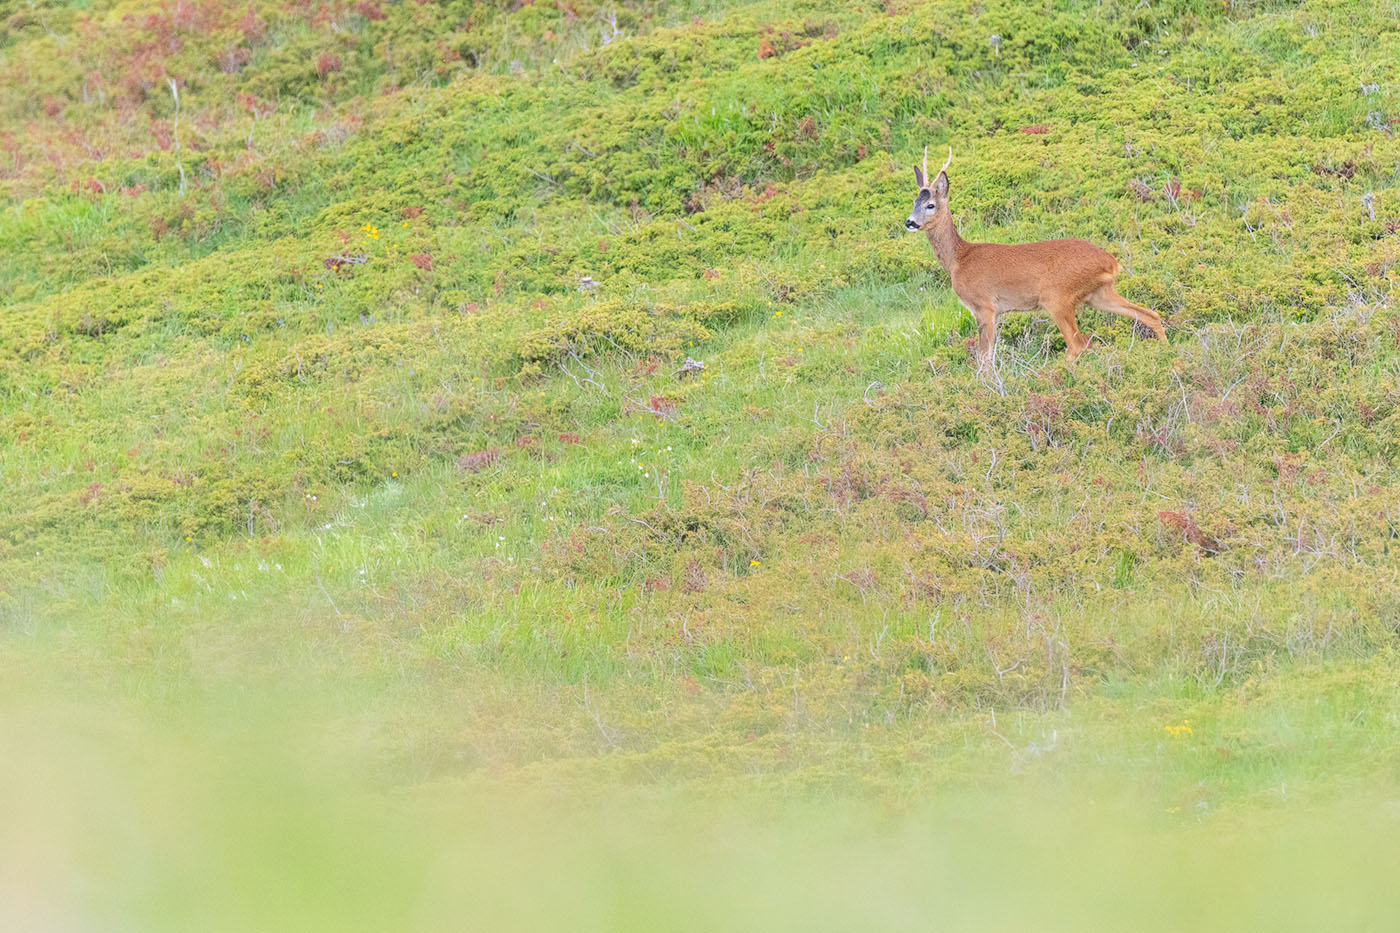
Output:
[904, 146, 1166, 371]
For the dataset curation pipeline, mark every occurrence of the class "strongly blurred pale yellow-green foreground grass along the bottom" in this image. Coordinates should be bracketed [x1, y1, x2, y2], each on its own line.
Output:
[10, 700, 1400, 930]
